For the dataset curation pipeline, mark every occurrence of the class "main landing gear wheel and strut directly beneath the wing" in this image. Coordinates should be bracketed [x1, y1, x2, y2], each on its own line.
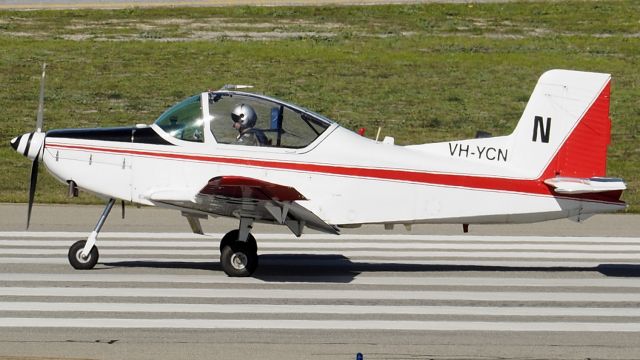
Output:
[220, 218, 258, 277]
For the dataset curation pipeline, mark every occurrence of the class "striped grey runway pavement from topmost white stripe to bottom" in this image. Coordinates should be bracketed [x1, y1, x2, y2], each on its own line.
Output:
[0, 225, 640, 359]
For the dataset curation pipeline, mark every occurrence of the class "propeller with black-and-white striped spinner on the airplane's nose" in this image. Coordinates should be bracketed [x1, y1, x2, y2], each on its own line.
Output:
[11, 63, 47, 229]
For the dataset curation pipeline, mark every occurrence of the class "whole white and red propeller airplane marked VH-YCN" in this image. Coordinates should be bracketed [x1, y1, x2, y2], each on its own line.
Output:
[11, 66, 626, 276]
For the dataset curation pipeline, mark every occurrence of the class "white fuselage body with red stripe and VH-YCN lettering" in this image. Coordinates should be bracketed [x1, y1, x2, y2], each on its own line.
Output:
[42, 89, 625, 225]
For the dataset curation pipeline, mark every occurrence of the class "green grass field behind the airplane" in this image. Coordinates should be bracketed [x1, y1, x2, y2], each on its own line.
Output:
[0, 1, 640, 212]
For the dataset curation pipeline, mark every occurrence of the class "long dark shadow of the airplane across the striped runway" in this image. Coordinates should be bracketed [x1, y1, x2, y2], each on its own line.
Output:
[102, 254, 640, 283]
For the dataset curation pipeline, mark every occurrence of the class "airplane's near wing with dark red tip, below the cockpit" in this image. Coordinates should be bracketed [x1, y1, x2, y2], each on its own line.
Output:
[144, 176, 338, 236]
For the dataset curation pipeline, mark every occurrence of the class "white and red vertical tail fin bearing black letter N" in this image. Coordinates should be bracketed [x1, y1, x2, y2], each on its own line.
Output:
[510, 70, 611, 180]
